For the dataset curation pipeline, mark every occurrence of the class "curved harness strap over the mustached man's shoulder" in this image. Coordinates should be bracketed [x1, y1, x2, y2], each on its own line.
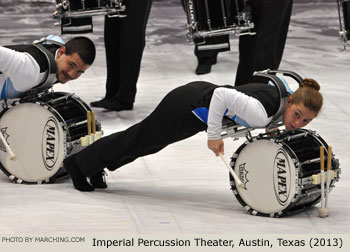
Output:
[33, 38, 63, 90]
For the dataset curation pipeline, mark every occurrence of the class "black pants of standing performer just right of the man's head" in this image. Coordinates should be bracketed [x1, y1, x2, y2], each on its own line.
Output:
[104, 0, 152, 104]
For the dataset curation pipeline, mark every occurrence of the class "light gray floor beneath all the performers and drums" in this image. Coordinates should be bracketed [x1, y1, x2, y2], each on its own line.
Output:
[0, 0, 350, 234]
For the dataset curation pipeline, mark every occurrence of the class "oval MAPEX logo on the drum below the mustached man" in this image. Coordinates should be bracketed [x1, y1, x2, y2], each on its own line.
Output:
[42, 117, 59, 171]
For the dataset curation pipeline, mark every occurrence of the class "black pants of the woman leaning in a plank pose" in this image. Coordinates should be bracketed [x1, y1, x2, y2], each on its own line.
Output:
[73, 82, 211, 176]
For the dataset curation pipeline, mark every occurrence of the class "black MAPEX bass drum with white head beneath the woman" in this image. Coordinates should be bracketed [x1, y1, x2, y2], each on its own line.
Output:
[230, 129, 340, 217]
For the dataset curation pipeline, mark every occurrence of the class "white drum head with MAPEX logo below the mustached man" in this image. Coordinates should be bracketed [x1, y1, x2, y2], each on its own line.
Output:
[0, 103, 66, 182]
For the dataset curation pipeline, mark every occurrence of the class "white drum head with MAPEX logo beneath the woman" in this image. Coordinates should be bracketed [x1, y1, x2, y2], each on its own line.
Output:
[234, 139, 298, 214]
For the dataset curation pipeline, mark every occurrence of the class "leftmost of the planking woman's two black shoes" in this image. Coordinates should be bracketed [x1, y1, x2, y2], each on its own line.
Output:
[63, 157, 94, 192]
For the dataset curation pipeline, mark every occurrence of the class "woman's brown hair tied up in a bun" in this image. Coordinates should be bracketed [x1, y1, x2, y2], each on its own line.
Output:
[292, 79, 323, 114]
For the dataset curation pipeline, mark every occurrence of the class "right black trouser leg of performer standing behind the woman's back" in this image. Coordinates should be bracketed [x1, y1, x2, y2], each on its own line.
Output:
[235, 0, 293, 86]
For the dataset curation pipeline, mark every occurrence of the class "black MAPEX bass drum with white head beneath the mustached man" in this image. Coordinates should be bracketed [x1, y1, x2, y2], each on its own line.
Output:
[0, 92, 100, 184]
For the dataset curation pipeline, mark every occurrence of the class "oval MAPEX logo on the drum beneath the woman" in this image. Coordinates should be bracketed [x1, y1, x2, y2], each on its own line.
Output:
[273, 149, 291, 206]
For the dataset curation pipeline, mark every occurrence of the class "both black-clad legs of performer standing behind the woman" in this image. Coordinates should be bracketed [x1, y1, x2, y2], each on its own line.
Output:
[182, 0, 293, 81]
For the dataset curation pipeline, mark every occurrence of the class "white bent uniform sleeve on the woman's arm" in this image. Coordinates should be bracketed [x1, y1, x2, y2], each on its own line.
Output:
[207, 87, 271, 140]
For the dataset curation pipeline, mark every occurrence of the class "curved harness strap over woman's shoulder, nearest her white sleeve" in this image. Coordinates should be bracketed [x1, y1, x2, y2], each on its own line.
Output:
[254, 70, 289, 129]
